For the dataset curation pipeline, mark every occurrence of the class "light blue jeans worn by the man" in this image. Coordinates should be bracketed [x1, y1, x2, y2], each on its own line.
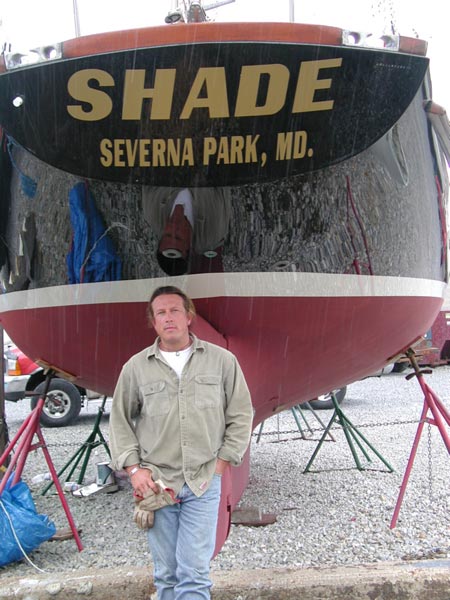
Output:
[148, 475, 221, 600]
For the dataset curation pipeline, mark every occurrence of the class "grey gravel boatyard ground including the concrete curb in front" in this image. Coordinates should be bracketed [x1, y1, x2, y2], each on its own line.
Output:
[0, 366, 450, 600]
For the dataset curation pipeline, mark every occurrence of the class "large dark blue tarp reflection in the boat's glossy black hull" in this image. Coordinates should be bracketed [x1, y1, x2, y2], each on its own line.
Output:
[67, 182, 122, 283]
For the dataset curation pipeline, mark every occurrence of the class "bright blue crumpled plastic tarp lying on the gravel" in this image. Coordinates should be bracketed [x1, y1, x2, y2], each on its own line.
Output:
[0, 475, 56, 566]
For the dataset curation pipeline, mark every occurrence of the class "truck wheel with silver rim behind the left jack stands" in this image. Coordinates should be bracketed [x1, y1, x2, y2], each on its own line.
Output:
[31, 378, 81, 427]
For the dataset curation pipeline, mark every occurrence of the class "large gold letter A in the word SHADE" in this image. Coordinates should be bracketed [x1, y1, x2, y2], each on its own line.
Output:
[180, 67, 230, 119]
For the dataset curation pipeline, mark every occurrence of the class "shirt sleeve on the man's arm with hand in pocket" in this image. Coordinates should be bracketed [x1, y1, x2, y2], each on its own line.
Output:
[218, 356, 253, 466]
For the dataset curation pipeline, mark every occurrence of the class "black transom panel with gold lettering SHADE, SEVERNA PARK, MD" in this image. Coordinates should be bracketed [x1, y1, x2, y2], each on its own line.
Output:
[0, 42, 428, 186]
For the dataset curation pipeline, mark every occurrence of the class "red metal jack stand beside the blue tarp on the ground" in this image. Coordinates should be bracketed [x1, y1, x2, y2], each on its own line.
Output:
[0, 371, 83, 552]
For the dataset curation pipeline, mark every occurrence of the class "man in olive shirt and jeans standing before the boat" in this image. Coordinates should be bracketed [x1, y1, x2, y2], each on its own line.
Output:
[110, 286, 253, 600]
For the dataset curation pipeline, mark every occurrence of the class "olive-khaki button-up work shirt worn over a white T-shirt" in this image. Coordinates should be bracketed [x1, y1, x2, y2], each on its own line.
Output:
[109, 335, 253, 496]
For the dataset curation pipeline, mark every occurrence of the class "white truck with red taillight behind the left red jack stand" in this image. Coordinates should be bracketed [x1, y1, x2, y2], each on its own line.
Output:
[4, 343, 100, 427]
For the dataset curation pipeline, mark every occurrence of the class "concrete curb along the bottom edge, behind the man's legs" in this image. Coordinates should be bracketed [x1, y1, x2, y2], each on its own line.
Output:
[0, 560, 450, 600]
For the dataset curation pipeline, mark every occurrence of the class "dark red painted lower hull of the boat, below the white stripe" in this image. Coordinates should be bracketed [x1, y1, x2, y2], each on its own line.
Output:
[2, 296, 442, 423]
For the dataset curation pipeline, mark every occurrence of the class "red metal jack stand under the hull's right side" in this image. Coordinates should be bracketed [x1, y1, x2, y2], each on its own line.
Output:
[390, 348, 450, 529]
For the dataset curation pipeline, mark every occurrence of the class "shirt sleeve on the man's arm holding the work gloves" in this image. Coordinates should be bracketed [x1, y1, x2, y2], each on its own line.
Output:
[109, 363, 140, 470]
